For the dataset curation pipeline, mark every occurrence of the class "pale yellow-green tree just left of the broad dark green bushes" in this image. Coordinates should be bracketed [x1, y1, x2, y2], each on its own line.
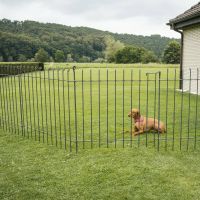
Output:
[104, 36, 124, 62]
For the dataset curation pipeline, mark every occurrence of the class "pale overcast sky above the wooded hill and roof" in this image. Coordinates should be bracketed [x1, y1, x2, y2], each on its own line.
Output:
[0, 0, 198, 38]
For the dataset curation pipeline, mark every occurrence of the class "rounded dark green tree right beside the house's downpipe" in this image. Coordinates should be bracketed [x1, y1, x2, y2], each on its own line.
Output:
[163, 41, 181, 64]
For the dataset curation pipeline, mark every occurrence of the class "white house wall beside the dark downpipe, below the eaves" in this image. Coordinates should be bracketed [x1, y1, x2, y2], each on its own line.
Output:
[183, 24, 200, 94]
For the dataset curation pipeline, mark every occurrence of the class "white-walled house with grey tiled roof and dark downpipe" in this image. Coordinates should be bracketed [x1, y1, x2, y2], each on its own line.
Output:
[167, 2, 200, 94]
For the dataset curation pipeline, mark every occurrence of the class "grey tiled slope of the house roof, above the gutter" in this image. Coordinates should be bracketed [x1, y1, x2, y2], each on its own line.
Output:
[169, 2, 200, 23]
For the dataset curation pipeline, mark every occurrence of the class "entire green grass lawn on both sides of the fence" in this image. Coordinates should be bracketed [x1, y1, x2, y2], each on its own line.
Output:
[0, 63, 200, 200]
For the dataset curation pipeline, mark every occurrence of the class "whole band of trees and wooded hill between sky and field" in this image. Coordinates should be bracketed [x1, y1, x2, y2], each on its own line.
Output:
[0, 19, 180, 63]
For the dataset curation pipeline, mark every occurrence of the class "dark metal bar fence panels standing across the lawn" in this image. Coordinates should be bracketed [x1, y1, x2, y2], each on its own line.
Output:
[0, 67, 200, 152]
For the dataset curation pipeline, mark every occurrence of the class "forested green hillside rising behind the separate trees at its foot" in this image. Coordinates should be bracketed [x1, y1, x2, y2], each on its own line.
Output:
[0, 19, 180, 62]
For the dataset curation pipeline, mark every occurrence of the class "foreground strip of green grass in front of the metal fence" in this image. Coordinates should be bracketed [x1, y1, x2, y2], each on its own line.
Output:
[0, 130, 200, 200]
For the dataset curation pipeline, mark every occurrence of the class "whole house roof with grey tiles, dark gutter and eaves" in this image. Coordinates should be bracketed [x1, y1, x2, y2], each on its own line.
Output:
[168, 2, 200, 28]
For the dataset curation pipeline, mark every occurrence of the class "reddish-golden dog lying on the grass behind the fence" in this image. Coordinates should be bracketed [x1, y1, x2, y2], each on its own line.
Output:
[128, 108, 166, 136]
